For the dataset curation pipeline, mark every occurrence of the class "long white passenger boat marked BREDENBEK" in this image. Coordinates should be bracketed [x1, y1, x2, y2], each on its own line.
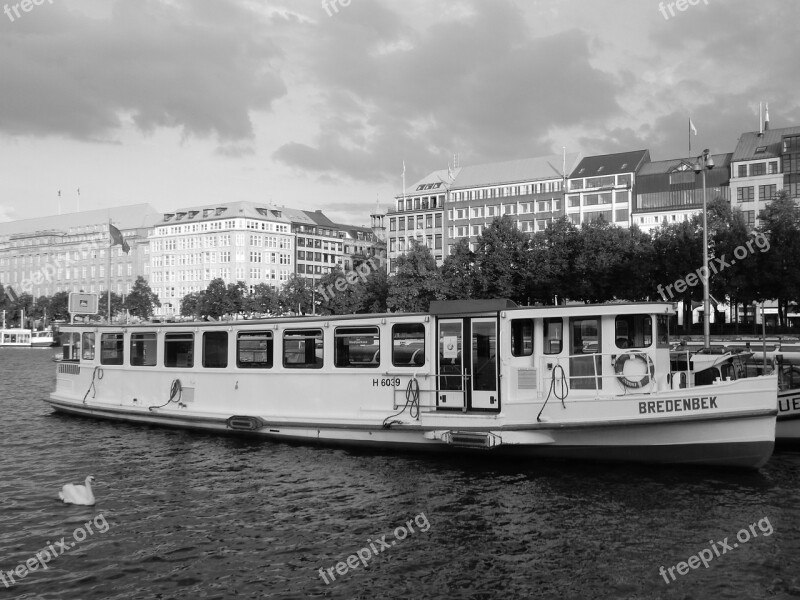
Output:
[46, 300, 777, 468]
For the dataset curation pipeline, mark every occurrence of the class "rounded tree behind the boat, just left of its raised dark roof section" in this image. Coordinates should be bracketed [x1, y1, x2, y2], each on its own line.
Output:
[386, 239, 442, 312]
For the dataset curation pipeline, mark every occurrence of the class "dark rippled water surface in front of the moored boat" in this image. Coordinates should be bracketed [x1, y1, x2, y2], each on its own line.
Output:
[0, 348, 800, 600]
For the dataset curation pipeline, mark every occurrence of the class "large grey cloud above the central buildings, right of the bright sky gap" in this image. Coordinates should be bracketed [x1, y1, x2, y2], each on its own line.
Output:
[274, 1, 620, 181]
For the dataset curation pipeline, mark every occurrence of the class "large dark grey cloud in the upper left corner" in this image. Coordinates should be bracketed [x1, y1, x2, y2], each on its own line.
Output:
[0, 0, 286, 141]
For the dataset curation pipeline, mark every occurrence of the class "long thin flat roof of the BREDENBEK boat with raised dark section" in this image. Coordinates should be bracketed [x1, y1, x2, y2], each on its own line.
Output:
[59, 299, 675, 330]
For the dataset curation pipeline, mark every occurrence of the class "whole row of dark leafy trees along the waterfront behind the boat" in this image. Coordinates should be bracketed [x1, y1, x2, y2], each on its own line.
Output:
[5, 192, 800, 326]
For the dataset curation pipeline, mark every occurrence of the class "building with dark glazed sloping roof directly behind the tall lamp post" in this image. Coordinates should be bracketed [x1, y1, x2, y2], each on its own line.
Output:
[631, 153, 733, 233]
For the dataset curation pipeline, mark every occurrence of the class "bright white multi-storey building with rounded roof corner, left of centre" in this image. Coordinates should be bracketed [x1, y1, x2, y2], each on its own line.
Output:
[150, 202, 294, 316]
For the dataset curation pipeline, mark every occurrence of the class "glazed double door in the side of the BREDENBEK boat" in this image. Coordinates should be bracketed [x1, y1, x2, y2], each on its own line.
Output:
[436, 317, 500, 411]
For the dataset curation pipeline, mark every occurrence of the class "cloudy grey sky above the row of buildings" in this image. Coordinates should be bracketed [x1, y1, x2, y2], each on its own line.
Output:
[0, 0, 800, 225]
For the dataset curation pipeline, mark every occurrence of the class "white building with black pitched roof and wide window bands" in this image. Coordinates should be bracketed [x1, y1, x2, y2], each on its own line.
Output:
[566, 150, 650, 227]
